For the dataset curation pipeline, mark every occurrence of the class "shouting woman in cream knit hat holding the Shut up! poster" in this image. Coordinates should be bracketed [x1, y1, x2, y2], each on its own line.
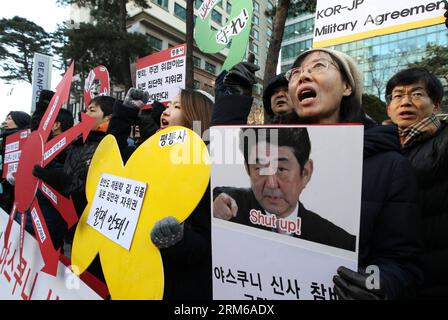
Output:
[214, 49, 423, 299]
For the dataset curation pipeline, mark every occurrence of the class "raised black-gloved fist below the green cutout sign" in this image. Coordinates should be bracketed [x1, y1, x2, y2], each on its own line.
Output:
[215, 56, 260, 96]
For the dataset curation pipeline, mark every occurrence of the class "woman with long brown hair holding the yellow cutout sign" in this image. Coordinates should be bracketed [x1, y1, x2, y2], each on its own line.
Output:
[110, 88, 213, 300]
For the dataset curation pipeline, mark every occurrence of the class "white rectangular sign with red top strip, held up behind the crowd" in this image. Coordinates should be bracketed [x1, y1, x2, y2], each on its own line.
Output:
[136, 44, 187, 104]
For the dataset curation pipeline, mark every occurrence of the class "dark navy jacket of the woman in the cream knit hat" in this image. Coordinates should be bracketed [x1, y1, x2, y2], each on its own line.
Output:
[359, 126, 423, 299]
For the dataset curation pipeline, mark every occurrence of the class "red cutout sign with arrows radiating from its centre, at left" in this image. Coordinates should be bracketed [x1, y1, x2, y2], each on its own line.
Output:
[4, 63, 94, 276]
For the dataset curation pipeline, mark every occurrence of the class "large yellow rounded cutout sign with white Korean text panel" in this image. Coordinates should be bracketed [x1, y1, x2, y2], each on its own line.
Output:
[72, 126, 210, 300]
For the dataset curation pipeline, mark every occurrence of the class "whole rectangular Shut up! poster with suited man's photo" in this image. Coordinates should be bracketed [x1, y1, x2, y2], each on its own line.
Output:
[210, 125, 363, 300]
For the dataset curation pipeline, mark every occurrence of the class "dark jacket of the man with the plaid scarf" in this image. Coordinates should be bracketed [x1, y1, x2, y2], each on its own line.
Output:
[402, 123, 448, 299]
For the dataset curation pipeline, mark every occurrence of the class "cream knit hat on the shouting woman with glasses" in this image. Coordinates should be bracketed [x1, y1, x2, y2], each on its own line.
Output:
[293, 48, 363, 105]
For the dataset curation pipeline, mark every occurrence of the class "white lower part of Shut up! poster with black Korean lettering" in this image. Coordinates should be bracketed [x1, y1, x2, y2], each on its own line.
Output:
[212, 219, 357, 300]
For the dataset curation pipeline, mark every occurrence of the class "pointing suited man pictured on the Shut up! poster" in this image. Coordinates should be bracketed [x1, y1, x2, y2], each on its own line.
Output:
[213, 127, 356, 251]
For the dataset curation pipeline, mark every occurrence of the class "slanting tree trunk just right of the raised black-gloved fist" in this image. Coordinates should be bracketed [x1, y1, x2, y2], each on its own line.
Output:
[263, 0, 291, 88]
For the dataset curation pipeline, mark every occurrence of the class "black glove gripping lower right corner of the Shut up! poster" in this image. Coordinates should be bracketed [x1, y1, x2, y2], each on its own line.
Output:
[333, 267, 386, 300]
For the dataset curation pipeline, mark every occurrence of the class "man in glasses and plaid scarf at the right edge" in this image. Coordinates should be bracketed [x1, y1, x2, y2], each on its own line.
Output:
[386, 68, 448, 299]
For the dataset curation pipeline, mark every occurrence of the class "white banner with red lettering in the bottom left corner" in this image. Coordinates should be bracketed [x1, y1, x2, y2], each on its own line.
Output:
[0, 209, 101, 300]
